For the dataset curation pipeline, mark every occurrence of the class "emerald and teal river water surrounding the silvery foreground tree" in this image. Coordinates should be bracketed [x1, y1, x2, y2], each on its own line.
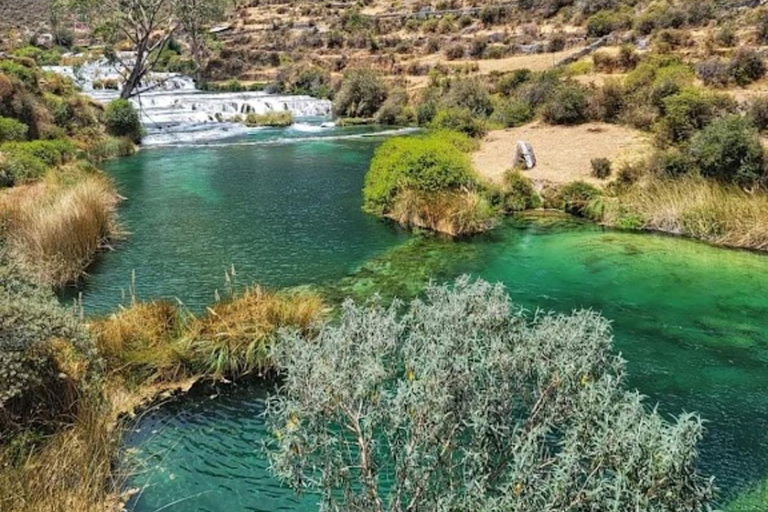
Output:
[78, 132, 768, 512]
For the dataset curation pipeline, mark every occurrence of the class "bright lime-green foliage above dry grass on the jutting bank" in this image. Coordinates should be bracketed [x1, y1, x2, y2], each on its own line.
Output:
[363, 133, 475, 214]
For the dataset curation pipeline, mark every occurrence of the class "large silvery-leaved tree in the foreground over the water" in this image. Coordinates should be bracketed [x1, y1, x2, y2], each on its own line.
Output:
[267, 278, 712, 512]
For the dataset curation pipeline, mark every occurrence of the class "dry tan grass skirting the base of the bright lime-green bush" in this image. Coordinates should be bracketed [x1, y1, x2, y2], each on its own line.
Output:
[388, 189, 497, 236]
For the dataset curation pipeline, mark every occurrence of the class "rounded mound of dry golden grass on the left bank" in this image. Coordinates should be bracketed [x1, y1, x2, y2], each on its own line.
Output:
[0, 175, 118, 286]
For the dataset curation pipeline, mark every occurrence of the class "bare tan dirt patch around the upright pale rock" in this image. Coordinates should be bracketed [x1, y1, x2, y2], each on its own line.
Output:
[472, 122, 650, 185]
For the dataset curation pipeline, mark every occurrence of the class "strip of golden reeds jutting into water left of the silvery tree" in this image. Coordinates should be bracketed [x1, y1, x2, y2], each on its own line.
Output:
[91, 286, 325, 385]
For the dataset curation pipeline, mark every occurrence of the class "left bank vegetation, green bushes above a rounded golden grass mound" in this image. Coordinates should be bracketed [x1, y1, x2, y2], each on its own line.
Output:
[0, 58, 135, 286]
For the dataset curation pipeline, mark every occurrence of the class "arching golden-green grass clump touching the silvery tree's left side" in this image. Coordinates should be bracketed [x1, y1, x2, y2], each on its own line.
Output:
[189, 286, 324, 378]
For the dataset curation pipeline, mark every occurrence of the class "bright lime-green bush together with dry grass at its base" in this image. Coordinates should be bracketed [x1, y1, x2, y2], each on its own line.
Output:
[363, 131, 496, 236]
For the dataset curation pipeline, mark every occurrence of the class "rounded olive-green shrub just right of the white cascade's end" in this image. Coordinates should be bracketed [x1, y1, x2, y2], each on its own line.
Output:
[333, 69, 389, 118]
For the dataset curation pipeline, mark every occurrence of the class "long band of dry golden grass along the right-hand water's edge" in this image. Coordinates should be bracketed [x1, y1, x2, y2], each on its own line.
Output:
[605, 177, 768, 251]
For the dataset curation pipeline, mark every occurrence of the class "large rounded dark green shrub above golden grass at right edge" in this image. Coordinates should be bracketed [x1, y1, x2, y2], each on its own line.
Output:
[690, 115, 765, 187]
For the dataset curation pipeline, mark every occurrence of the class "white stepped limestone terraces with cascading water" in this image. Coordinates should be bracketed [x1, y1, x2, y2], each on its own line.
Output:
[46, 54, 331, 145]
